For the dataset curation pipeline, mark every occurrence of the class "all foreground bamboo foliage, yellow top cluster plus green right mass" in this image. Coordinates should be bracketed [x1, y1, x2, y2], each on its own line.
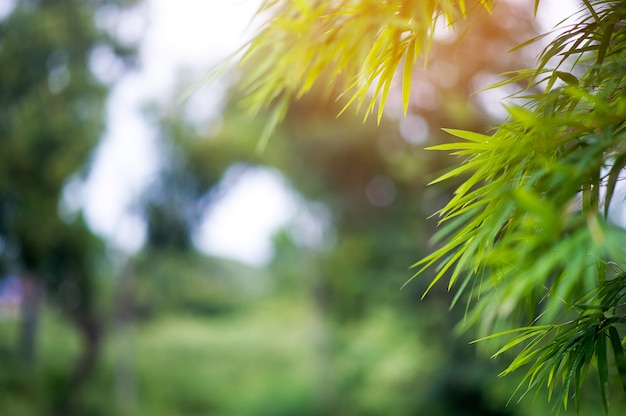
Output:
[232, 0, 626, 411]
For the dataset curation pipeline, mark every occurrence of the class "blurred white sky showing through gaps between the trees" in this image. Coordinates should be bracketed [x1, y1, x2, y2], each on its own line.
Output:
[80, 0, 575, 265]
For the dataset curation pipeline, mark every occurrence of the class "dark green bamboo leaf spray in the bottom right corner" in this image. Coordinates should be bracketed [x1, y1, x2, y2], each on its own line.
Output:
[476, 266, 626, 413]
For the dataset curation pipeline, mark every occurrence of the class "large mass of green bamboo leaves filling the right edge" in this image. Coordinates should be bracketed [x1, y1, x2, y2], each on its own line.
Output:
[415, 1, 626, 409]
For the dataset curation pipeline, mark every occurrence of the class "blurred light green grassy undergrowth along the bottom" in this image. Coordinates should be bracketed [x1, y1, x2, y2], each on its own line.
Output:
[0, 267, 600, 416]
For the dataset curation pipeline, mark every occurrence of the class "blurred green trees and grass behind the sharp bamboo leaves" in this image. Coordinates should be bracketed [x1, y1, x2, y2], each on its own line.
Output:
[0, 0, 617, 416]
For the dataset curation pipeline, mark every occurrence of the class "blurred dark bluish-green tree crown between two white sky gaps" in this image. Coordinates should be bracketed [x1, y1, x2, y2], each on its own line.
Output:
[139, 108, 250, 253]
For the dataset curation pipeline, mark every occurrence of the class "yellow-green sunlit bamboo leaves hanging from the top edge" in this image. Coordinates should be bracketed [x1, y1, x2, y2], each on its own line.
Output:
[239, 0, 493, 146]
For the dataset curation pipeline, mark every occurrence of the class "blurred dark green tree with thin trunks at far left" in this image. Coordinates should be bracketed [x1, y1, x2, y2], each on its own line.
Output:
[0, 0, 134, 404]
